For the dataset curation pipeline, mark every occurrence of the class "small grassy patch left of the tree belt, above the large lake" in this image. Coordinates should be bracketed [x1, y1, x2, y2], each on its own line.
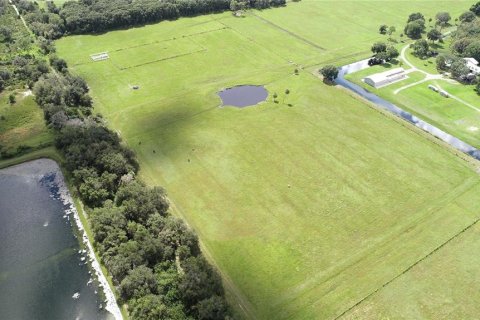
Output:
[0, 92, 53, 153]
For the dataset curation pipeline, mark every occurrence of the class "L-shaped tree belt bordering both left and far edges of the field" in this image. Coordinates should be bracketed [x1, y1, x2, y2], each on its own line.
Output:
[9, 0, 292, 320]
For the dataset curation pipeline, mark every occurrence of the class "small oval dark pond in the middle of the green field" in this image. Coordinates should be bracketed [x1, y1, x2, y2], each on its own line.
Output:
[218, 85, 268, 108]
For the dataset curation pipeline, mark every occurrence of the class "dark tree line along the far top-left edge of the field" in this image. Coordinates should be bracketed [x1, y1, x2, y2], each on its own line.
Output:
[14, 0, 286, 40]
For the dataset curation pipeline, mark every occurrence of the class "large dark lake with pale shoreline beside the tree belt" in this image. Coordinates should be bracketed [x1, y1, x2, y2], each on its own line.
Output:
[0, 160, 113, 320]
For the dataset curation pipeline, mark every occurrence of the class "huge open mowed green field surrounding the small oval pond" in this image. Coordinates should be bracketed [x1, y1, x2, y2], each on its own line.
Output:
[57, 0, 480, 319]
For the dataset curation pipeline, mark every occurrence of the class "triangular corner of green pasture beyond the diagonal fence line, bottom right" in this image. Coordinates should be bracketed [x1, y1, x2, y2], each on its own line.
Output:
[345, 220, 480, 319]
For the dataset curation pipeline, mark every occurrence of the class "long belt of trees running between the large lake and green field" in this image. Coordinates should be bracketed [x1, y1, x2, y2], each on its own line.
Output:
[10, 0, 231, 320]
